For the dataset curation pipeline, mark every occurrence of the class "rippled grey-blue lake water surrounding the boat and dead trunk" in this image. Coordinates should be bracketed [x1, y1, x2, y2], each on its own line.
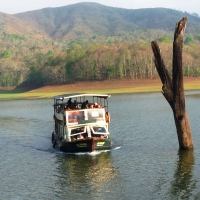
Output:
[0, 91, 200, 200]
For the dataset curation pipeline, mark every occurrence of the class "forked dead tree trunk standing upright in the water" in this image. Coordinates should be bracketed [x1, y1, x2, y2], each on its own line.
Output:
[151, 18, 193, 149]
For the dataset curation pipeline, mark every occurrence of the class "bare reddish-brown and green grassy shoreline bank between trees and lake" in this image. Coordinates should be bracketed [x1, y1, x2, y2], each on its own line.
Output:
[0, 77, 200, 100]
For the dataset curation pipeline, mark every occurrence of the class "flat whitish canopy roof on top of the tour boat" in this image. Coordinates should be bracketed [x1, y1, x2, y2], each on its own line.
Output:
[53, 94, 111, 100]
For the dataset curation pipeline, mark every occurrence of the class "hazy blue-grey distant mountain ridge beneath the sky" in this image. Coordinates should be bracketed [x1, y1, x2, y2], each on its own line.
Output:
[8, 3, 200, 41]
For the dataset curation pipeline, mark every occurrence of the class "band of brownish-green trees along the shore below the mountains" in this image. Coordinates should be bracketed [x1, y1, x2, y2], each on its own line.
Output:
[0, 41, 200, 87]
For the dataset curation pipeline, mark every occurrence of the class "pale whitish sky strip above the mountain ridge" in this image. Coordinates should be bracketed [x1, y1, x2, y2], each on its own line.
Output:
[0, 0, 200, 16]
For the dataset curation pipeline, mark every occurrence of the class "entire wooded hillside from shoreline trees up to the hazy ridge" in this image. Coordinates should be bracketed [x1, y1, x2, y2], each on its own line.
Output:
[0, 3, 200, 87]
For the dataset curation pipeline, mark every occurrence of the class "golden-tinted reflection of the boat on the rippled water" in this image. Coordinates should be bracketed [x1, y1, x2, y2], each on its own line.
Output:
[55, 152, 116, 197]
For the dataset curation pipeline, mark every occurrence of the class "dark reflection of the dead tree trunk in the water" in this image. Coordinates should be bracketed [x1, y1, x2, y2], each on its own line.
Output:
[170, 149, 196, 199]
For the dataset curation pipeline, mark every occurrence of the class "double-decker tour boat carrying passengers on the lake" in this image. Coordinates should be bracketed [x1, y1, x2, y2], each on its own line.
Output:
[52, 94, 112, 152]
